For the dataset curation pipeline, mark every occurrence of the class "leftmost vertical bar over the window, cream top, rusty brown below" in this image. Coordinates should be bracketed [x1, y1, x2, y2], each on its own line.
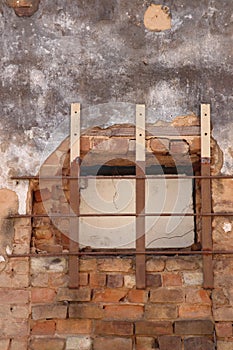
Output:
[69, 103, 80, 288]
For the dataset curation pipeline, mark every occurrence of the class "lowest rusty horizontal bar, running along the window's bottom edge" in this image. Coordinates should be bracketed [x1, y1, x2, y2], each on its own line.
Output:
[7, 250, 233, 258]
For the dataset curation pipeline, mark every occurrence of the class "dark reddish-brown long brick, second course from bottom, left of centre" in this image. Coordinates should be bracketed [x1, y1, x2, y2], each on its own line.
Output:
[95, 321, 133, 336]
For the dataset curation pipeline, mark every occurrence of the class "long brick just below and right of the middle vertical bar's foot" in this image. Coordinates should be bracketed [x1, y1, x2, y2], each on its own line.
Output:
[150, 288, 185, 303]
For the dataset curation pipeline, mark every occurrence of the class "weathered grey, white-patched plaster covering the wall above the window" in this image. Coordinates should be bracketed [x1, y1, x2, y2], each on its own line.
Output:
[0, 0, 233, 208]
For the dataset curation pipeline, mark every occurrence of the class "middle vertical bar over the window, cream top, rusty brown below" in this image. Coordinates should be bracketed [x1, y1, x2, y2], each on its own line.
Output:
[136, 105, 146, 289]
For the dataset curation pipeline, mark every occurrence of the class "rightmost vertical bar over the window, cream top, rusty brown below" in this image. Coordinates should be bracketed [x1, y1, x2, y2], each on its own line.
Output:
[201, 104, 214, 289]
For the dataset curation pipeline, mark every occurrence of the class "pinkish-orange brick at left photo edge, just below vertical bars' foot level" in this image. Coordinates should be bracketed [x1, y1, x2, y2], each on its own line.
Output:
[0, 288, 29, 304]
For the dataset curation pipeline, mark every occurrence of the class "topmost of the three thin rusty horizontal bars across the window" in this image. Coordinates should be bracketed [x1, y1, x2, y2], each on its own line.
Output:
[11, 175, 233, 180]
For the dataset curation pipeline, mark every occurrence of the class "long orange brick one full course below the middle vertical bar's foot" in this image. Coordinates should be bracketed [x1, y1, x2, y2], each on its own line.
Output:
[104, 305, 143, 320]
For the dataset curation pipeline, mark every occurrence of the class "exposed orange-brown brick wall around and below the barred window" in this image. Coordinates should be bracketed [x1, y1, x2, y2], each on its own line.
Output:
[0, 119, 233, 350]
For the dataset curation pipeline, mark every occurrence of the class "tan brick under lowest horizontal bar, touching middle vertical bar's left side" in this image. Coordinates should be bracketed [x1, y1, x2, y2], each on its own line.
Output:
[98, 258, 132, 272]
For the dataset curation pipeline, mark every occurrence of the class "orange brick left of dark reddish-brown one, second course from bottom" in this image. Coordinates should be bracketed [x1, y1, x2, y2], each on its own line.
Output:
[56, 319, 92, 334]
